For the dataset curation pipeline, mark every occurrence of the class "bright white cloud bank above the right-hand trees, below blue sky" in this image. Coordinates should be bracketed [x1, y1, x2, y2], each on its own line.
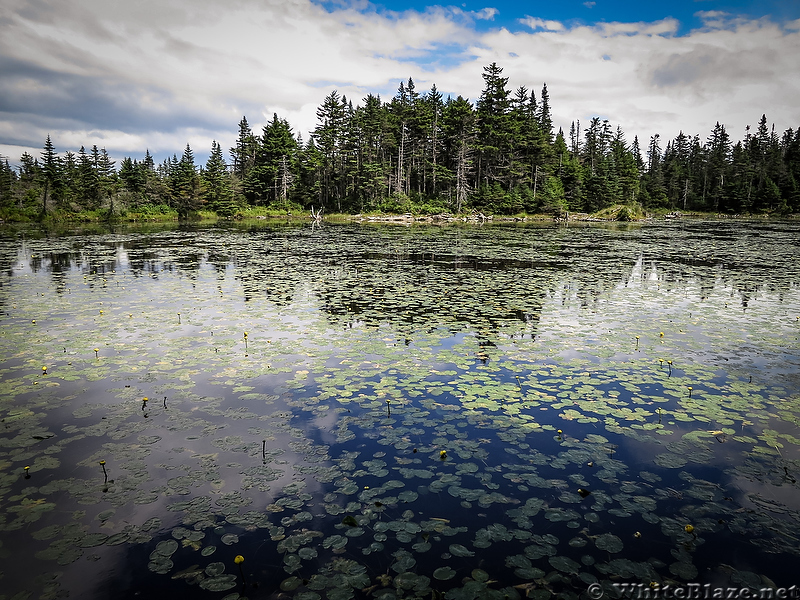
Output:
[459, 13, 800, 141]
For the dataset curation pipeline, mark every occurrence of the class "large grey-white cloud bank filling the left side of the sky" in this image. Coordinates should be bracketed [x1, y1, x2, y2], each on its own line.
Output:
[0, 0, 482, 161]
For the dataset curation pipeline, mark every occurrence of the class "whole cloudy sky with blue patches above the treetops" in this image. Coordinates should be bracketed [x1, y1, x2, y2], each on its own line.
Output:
[0, 0, 800, 165]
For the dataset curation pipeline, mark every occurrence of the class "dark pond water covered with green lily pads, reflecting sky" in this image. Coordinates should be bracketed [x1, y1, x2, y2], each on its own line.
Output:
[0, 221, 800, 600]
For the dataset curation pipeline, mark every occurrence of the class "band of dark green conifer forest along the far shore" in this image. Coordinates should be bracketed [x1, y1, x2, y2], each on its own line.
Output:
[0, 63, 800, 221]
